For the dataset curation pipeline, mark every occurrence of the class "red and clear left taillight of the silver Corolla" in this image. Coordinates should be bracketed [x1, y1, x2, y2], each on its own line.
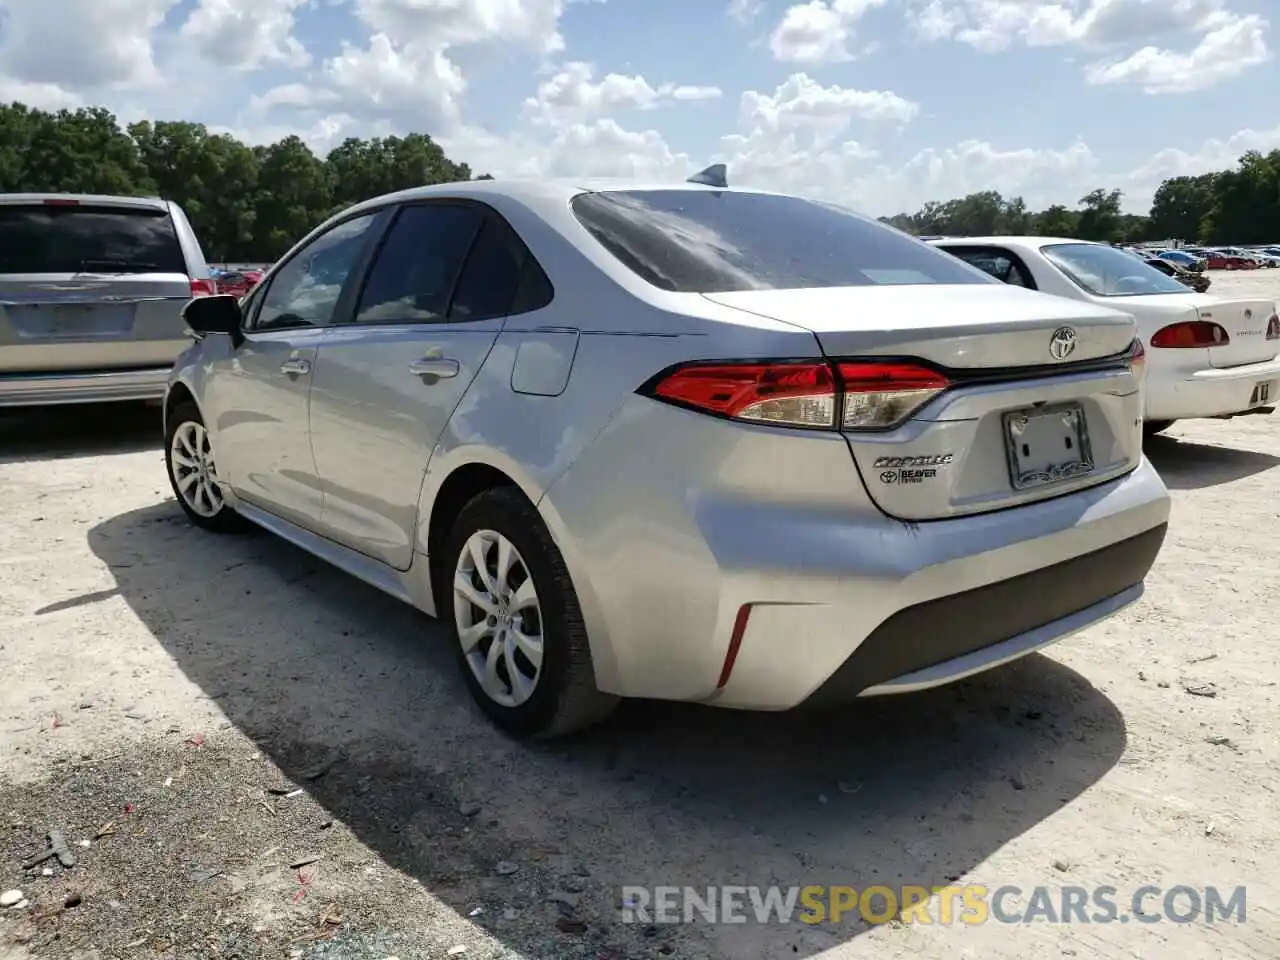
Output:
[644, 361, 951, 430]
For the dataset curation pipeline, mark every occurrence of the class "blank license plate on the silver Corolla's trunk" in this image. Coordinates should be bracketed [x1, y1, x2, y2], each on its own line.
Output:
[1005, 403, 1093, 490]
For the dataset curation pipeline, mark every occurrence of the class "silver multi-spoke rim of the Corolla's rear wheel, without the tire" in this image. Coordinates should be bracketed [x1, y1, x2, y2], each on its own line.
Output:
[453, 530, 543, 708]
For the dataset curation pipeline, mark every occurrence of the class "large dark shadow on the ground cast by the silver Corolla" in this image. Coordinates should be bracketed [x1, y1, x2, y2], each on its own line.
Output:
[90, 500, 1125, 957]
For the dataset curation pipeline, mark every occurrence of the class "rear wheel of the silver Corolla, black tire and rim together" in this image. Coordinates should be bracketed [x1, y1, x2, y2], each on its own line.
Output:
[439, 488, 618, 739]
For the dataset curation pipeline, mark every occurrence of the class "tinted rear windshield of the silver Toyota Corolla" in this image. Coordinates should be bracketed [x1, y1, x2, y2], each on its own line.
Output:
[572, 189, 998, 293]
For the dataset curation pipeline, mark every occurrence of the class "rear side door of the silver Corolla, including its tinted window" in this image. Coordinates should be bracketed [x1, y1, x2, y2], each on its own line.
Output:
[311, 201, 525, 570]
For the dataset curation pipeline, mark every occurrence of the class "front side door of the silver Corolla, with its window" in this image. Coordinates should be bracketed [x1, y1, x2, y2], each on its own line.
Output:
[205, 214, 378, 530]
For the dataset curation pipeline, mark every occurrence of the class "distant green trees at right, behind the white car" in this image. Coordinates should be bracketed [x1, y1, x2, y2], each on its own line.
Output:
[881, 150, 1280, 244]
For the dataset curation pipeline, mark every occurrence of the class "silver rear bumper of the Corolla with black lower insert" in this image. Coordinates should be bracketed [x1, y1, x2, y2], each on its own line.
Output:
[539, 396, 1170, 710]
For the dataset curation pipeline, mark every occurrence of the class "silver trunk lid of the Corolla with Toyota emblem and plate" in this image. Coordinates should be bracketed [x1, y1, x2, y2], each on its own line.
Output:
[708, 284, 1142, 521]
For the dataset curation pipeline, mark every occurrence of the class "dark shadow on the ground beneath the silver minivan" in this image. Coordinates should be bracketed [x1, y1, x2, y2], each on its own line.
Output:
[0, 403, 164, 463]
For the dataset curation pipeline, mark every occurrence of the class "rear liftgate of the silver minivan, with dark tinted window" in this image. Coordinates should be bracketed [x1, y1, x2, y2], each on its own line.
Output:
[0, 198, 192, 374]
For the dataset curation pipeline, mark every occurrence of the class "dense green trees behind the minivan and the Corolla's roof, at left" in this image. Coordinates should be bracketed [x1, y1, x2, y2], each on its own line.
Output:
[0, 102, 486, 262]
